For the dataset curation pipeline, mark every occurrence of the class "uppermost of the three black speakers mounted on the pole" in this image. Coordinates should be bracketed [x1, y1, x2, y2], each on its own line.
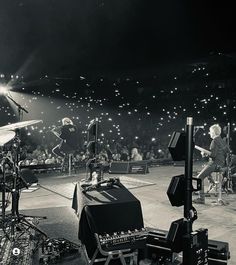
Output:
[168, 132, 185, 161]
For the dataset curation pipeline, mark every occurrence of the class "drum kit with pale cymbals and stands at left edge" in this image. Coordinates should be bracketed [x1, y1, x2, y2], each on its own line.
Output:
[0, 120, 46, 241]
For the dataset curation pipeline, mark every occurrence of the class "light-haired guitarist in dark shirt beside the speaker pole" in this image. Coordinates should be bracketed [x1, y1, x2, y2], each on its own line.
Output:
[193, 124, 229, 204]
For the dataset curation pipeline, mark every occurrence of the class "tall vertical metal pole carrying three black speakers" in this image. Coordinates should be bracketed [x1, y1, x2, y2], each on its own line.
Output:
[184, 117, 193, 234]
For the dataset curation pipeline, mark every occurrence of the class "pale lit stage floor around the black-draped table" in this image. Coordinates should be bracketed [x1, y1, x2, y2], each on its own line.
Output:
[4, 164, 236, 265]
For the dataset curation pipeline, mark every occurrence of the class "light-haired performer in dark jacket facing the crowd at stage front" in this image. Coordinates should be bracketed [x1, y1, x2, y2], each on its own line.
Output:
[52, 117, 79, 158]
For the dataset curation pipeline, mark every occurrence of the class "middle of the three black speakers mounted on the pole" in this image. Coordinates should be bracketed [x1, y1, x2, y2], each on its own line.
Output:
[167, 175, 185, 207]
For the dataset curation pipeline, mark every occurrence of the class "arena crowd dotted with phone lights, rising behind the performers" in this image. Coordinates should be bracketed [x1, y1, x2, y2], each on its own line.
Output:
[0, 58, 236, 169]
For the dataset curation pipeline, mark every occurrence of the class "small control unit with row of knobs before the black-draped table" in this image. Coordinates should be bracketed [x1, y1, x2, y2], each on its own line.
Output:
[95, 228, 147, 251]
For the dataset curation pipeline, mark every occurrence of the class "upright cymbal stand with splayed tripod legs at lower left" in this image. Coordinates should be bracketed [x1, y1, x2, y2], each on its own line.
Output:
[3, 134, 48, 241]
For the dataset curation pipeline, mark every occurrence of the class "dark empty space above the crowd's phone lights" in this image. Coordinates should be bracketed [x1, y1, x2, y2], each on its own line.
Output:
[0, 0, 236, 77]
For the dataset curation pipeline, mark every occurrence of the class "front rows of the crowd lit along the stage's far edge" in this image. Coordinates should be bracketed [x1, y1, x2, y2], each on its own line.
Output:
[20, 139, 170, 167]
